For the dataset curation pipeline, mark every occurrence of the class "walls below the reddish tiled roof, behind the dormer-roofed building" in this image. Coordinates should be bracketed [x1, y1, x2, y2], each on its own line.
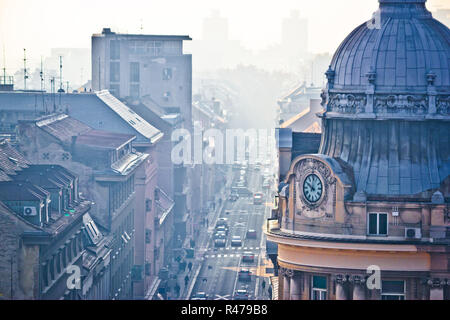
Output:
[15, 124, 136, 299]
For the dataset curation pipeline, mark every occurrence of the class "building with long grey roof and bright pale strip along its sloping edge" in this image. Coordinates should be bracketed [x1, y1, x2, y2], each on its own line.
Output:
[0, 90, 173, 299]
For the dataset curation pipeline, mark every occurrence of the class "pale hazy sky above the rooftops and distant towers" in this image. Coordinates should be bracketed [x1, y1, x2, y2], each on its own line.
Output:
[0, 0, 450, 70]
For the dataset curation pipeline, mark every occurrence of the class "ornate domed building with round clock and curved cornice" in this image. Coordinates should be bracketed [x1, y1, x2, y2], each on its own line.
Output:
[266, 0, 450, 300]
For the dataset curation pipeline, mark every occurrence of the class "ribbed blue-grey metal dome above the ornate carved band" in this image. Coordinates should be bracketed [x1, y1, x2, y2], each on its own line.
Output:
[327, 0, 450, 92]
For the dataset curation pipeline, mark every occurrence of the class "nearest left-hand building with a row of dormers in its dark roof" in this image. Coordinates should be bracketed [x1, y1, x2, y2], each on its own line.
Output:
[0, 140, 111, 300]
